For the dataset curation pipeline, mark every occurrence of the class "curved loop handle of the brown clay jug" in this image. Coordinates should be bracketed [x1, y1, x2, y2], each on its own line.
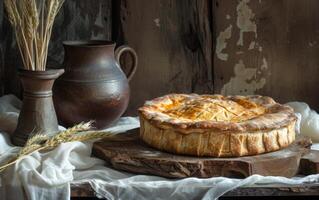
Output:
[115, 45, 138, 81]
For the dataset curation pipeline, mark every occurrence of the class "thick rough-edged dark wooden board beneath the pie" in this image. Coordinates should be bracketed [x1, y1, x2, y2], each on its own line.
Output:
[93, 129, 319, 178]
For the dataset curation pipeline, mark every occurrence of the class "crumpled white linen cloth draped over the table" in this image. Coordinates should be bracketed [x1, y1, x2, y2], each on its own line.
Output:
[0, 95, 319, 200]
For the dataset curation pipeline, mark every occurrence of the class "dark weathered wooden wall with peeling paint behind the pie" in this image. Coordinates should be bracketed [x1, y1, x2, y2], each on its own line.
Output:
[0, 0, 319, 115]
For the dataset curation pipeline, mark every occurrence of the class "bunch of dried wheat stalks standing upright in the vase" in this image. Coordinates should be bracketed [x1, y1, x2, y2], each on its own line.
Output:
[4, 0, 64, 71]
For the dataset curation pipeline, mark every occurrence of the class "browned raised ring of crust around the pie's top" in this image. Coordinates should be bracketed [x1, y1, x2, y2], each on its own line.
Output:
[139, 94, 296, 134]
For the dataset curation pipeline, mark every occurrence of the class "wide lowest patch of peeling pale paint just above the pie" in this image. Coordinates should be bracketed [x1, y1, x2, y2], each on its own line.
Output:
[221, 60, 266, 95]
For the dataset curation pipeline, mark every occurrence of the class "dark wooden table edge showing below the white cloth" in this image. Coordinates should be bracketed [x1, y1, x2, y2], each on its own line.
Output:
[71, 184, 319, 198]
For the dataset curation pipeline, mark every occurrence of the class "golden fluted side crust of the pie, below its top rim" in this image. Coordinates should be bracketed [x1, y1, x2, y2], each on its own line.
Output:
[140, 115, 296, 157]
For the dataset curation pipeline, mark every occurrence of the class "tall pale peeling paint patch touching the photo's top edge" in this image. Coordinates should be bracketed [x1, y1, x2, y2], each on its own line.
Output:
[237, 0, 257, 46]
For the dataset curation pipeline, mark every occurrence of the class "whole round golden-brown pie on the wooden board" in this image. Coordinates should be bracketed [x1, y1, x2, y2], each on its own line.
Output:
[139, 94, 296, 157]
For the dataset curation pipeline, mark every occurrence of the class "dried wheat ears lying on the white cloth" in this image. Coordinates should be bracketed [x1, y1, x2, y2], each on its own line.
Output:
[0, 122, 113, 172]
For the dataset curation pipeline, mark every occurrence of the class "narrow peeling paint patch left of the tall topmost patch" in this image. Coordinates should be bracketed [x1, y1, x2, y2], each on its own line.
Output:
[216, 25, 233, 61]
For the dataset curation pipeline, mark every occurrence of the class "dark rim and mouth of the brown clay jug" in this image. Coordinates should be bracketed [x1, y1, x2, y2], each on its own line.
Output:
[62, 40, 116, 48]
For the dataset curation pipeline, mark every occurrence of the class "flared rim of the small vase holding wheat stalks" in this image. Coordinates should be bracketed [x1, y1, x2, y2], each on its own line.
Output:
[19, 69, 64, 79]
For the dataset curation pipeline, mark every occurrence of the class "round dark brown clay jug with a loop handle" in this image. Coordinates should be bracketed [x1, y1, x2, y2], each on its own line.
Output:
[53, 41, 137, 129]
